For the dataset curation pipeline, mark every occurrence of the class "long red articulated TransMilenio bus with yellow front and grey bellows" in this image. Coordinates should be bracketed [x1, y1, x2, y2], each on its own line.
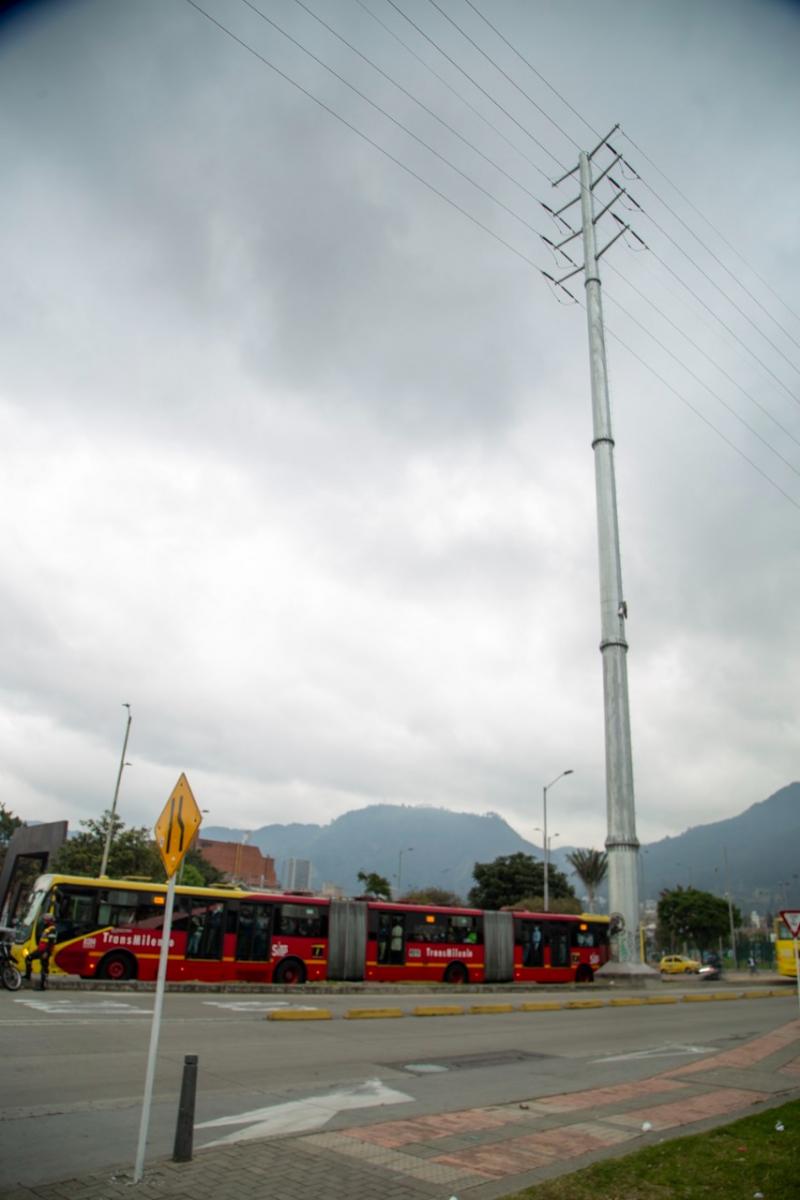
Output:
[14, 875, 608, 984]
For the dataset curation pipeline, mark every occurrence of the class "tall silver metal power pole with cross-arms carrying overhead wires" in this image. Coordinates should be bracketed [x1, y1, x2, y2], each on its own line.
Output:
[546, 127, 650, 974]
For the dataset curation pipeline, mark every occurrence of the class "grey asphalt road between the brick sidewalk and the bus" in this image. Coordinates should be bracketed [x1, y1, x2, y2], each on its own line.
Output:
[0, 990, 796, 1186]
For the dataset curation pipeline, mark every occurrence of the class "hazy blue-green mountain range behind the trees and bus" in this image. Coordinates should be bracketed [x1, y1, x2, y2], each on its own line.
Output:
[203, 782, 800, 914]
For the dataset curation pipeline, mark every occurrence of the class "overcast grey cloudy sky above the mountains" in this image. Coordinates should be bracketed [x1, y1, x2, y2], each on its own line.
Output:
[0, 0, 800, 846]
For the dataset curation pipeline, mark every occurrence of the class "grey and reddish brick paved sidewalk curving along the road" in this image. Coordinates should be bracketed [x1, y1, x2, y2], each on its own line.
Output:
[6, 1020, 800, 1200]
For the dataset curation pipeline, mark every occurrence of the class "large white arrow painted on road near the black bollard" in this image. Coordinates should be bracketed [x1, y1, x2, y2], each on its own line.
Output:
[194, 1079, 413, 1150]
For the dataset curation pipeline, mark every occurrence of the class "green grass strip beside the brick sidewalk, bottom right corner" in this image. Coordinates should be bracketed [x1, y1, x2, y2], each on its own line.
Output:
[506, 1100, 800, 1200]
